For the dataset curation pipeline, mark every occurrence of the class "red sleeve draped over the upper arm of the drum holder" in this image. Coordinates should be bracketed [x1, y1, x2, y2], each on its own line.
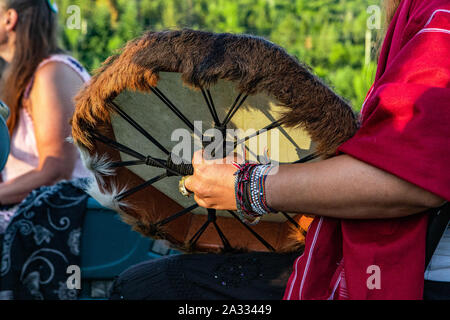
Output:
[339, 12, 450, 200]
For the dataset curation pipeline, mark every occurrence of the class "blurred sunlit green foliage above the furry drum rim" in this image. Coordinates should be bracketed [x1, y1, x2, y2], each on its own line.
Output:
[56, 0, 381, 110]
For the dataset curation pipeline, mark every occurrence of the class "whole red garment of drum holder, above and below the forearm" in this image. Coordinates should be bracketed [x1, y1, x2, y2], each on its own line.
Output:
[284, 0, 450, 300]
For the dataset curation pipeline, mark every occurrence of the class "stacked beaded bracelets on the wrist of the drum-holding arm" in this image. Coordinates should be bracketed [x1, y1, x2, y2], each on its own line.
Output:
[234, 163, 276, 225]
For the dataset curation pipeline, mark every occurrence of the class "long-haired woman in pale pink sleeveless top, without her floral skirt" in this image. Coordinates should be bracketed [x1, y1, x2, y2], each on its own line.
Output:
[0, 0, 89, 231]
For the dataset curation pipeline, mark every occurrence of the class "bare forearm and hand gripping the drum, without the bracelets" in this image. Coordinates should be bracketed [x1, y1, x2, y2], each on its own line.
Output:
[186, 153, 445, 219]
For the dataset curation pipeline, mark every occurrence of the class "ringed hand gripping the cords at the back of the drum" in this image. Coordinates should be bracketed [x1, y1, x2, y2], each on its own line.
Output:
[185, 151, 239, 210]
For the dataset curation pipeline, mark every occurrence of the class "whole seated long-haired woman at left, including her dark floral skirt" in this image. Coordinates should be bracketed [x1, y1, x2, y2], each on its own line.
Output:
[0, 0, 89, 299]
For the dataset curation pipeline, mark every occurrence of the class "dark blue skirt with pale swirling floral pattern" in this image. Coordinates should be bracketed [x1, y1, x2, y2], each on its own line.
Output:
[0, 179, 88, 300]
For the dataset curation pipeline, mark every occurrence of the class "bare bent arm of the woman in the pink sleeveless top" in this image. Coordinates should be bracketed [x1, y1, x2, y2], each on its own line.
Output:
[0, 63, 83, 204]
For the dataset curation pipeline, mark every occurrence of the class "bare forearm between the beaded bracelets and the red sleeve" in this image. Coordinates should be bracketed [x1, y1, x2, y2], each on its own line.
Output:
[266, 155, 445, 219]
